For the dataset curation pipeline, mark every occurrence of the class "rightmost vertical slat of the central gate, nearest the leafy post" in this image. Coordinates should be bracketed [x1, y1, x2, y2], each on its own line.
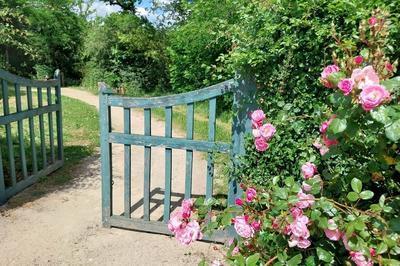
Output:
[206, 98, 217, 199]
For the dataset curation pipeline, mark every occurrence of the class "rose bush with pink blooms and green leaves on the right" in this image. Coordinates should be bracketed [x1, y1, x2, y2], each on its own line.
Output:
[170, 10, 400, 266]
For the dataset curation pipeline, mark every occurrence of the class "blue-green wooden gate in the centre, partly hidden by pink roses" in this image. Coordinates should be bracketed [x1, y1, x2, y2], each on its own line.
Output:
[99, 72, 256, 237]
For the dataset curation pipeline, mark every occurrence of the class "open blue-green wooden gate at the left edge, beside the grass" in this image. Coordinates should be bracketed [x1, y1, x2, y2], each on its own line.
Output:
[0, 69, 64, 204]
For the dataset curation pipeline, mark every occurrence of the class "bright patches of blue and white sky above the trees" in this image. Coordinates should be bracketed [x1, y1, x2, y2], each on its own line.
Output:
[93, 0, 170, 22]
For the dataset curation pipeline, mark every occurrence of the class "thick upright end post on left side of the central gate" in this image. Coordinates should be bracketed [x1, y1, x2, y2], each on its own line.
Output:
[99, 82, 112, 227]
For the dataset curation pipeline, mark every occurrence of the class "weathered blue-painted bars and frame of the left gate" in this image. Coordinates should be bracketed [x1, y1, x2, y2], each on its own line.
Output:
[0, 70, 64, 204]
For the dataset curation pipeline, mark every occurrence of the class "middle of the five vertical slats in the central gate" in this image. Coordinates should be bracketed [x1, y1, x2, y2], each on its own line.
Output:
[164, 106, 172, 222]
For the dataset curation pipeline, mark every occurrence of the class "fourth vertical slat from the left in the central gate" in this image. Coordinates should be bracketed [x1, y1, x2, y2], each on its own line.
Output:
[185, 103, 194, 199]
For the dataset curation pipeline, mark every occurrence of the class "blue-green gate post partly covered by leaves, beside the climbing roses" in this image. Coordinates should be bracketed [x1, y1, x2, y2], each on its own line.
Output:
[228, 71, 257, 205]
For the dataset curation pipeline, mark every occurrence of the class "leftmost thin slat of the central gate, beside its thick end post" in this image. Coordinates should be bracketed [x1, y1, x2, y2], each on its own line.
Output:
[124, 108, 132, 218]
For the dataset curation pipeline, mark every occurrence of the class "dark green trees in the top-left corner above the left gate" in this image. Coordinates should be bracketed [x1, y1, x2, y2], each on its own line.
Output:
[0, 0, 85, 79]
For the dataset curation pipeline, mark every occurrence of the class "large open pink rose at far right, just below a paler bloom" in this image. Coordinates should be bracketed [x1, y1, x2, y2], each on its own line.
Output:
[360, 85, 390, 111]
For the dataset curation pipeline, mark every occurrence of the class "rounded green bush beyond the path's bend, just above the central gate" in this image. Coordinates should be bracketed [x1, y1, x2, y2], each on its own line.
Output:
[83, 13, 168, 95]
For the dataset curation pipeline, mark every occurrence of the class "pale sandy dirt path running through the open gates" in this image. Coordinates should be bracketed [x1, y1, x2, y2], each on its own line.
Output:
[0, 88, 220, 265]
